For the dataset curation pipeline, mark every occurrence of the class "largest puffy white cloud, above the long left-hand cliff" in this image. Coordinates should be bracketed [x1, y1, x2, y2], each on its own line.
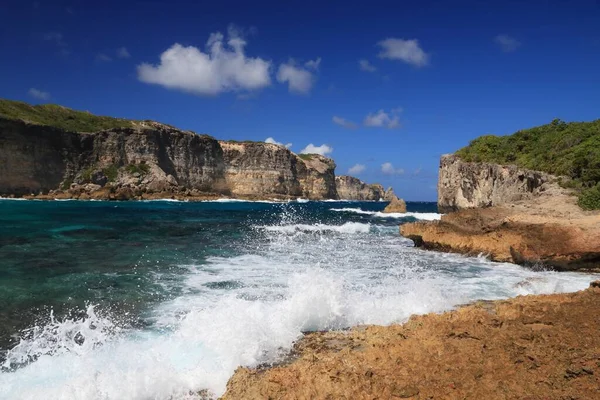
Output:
[137, 27, 271, 95]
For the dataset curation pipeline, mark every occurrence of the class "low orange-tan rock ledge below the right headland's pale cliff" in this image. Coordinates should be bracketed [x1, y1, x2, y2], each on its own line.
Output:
[400, 185, 600, 270]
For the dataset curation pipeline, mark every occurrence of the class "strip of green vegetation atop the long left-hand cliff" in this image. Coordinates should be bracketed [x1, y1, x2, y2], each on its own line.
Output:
[0, 99, 134, 132]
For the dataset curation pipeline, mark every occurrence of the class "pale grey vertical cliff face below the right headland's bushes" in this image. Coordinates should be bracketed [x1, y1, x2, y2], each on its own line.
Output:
[438, 154, 556, 213]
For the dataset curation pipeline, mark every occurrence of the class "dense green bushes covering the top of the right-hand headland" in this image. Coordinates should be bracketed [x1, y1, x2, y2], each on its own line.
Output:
[456, 119, 600, 209]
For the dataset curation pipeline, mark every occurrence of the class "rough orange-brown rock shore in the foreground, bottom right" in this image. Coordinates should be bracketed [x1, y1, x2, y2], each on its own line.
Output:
[222, 282, 600, 400]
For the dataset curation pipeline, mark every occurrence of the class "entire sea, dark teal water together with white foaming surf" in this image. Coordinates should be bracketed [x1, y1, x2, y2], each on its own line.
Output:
[0, 200, 597, 399]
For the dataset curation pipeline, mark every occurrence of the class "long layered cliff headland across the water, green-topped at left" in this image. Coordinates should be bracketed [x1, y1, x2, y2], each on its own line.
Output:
[0, 100, 394, 200]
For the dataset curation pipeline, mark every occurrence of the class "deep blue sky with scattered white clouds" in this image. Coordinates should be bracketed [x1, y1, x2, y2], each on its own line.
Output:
[0, 0, 600, 200]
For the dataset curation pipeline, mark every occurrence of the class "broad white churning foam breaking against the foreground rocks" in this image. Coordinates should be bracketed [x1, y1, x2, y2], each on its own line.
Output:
[0, 211, 594, 399]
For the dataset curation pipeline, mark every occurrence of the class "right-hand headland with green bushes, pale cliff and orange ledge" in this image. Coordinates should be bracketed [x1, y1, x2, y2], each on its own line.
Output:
[400, 120, 600, 271]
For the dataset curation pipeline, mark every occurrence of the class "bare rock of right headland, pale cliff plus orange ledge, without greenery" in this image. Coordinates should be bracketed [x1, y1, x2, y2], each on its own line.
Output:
[400, 156, 600, 271]
